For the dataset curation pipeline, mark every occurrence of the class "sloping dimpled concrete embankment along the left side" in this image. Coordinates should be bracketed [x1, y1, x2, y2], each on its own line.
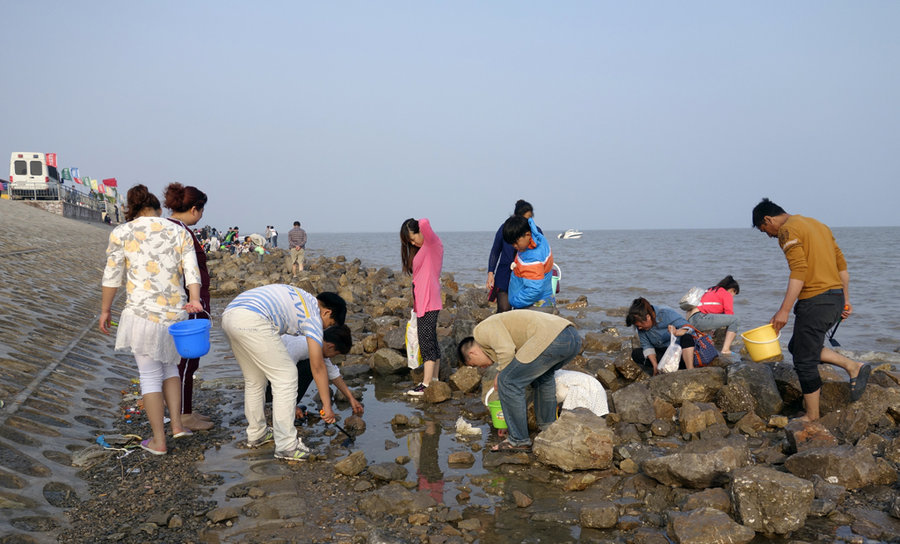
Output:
[0, 200, 129, 542]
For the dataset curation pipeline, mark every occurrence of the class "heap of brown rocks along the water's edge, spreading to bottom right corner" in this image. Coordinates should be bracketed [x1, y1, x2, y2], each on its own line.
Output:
[204, 253, 900, 543]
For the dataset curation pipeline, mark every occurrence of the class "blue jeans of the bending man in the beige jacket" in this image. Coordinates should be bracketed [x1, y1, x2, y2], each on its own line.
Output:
[498, 326, 581, 446]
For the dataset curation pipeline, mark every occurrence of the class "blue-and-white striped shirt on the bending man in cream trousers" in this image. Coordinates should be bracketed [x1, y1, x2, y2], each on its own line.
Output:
[224, 283, 322, 345]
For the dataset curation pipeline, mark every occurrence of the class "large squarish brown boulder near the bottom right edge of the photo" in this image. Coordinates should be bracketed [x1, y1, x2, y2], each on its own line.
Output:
[731, 465, 815, 534]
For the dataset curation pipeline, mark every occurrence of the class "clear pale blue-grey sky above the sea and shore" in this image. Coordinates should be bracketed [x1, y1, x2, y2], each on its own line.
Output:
[0, 0, 900, 233]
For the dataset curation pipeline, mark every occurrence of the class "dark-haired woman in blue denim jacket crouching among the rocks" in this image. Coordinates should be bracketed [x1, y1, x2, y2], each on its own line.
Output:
[625, 297, 694, 376]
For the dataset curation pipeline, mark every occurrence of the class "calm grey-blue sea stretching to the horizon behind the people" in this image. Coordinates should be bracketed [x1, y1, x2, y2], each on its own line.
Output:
[308, 227, 900, 352]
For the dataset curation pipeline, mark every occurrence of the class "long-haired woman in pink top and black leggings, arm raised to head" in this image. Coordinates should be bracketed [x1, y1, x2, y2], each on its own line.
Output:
[400, 218, 444, 397]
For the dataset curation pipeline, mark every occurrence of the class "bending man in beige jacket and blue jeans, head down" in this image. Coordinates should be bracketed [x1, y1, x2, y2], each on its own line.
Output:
[458, 310, 581, 451]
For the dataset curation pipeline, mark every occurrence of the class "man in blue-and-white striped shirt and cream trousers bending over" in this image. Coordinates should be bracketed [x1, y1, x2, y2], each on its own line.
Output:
[222, 284, 347, 461]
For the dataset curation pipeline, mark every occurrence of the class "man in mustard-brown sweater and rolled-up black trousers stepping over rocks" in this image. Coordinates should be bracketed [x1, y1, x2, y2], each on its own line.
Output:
[753, 198, 872, 421]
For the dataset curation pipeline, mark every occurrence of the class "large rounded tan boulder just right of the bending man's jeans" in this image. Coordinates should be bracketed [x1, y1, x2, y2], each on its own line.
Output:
[533, 408, 613, 472]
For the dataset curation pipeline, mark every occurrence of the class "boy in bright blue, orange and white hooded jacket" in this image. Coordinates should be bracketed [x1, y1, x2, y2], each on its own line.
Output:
[503, 215, 554, 309]
